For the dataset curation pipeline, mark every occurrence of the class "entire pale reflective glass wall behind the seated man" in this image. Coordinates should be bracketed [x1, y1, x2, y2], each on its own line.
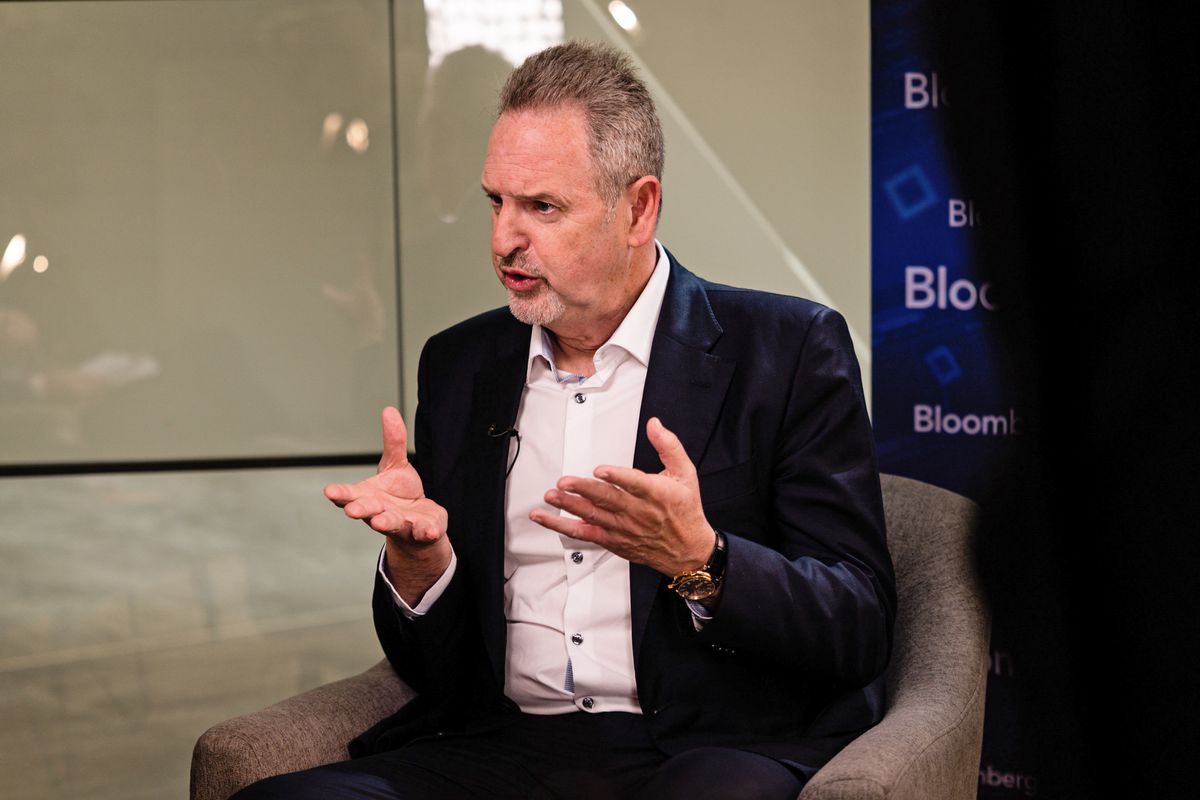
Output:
[0, 0, 869, 800]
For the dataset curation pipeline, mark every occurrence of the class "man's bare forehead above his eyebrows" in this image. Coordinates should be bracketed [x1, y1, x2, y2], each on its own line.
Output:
[484, 106, 593, 196]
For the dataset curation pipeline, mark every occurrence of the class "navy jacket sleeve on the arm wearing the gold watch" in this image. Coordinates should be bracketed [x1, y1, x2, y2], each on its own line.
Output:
[697, 308, 895, 686]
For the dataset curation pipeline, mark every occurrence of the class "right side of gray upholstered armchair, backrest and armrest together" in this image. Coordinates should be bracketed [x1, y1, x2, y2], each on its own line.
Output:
[800, 475, 990, 800]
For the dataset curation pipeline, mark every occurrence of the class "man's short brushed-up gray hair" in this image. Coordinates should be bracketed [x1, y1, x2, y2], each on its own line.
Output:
[499, 42, 664, 207]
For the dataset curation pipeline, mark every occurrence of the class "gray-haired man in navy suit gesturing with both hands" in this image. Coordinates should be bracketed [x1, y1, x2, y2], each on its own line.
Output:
[234, 43, 894, 799]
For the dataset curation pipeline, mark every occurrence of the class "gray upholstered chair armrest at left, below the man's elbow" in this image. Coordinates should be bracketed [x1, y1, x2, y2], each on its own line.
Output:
[191, 661, 415, 800]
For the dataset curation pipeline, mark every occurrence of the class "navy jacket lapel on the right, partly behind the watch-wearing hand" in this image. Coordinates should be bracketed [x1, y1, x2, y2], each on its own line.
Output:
[630, 253, 736, 662]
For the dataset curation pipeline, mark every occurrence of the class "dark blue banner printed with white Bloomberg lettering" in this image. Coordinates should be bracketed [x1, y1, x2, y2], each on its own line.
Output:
[871, 0, 1038, 799]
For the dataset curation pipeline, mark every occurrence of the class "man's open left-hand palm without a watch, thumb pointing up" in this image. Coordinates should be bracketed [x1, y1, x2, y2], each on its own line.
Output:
[325, 407, 450, 601]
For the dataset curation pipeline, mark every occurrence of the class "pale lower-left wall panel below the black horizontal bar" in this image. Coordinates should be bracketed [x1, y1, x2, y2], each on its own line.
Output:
[0, 468, 380, 800]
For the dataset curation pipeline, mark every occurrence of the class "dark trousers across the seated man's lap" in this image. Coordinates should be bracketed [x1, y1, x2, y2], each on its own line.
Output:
[234, 714, 805, 800]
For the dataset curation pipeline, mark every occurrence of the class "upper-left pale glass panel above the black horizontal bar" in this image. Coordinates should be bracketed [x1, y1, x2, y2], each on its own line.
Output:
[0, 0, 398, 464]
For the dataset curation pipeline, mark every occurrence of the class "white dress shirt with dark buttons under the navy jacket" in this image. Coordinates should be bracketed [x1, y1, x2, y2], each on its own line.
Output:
[379, 242, 670, 714]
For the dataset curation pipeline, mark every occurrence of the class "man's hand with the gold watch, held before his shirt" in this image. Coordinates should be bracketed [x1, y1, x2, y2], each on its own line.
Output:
[529, 417, 716, 576]
